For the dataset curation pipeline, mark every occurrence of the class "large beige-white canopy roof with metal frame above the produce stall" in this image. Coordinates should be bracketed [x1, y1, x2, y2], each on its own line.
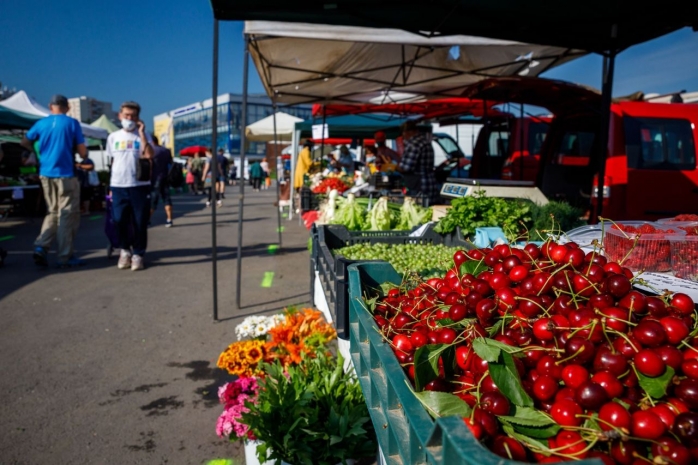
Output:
[245, 21, 586, 104]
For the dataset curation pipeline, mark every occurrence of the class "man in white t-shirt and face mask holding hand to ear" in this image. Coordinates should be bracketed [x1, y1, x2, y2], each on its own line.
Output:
[107, 102, 153, 271]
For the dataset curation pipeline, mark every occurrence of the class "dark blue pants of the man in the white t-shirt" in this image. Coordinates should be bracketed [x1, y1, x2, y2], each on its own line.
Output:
[111, 185, 150, 256]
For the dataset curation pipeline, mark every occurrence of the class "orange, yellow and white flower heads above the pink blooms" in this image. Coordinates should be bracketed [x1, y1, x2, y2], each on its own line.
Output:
[217, 308, 337, 376]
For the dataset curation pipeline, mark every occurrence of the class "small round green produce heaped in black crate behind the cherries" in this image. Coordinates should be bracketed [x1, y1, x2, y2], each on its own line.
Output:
[334, 243, 459, 276]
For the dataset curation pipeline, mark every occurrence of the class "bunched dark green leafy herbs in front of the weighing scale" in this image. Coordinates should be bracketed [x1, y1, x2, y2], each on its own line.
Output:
[434, 191, 531, 240]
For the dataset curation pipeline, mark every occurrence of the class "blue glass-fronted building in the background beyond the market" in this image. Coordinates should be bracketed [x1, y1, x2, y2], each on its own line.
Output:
[159, 94, 312, 157]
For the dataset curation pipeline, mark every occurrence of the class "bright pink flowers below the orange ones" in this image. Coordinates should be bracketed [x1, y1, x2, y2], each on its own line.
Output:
[216, 377, 259, 441]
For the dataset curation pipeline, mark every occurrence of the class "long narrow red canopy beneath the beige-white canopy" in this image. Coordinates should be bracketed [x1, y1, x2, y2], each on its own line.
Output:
[313, 97, 501, 119]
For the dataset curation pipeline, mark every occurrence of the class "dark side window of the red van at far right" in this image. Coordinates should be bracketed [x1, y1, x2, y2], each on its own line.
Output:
[624, 116, 696, 170]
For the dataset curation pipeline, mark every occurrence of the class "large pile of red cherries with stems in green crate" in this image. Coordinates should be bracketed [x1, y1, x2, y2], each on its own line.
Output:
[371, 242, 698, 465]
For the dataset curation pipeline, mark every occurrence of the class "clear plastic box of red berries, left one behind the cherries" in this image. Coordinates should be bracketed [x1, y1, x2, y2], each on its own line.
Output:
[604, 223, 683, 271]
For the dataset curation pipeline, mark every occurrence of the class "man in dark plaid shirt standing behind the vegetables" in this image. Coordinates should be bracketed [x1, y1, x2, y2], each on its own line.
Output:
[397, 121, 439, 205]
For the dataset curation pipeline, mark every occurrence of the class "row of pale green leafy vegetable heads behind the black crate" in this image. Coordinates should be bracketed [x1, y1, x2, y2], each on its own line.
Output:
[320, 192, 432, 231]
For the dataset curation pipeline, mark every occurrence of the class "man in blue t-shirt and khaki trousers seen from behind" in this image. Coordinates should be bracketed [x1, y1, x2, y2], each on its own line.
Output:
[22, 95, 87, 268]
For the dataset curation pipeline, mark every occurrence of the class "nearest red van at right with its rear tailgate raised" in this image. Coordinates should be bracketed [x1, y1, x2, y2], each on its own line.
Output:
[467, 78, 698, 220]
